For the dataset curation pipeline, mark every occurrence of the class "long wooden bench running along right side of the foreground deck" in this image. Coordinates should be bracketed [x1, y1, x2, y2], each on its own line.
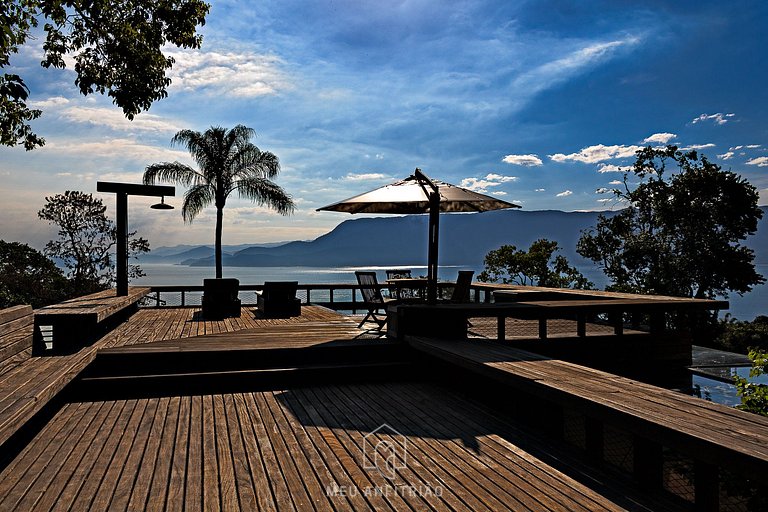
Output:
[406, 337, 768, 510]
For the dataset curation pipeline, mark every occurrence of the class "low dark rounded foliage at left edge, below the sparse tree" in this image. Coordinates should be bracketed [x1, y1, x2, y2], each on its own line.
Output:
[0, 240, 67, 308]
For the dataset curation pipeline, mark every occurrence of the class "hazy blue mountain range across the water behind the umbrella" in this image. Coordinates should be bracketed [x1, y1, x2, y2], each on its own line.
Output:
[140, 207, 768, 267]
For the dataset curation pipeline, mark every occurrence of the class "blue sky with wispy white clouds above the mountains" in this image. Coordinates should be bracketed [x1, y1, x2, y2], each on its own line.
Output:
[0, 0, 768, 248]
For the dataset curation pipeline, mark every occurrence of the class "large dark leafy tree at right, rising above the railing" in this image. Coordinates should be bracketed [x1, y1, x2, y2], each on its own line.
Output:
[577, 146, 765, 298]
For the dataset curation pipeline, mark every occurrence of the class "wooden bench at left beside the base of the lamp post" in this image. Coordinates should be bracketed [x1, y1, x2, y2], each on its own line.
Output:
[32, 287, 150, 355]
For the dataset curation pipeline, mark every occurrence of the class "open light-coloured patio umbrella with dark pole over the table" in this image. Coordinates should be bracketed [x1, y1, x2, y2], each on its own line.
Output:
[318, 168, 520, 304]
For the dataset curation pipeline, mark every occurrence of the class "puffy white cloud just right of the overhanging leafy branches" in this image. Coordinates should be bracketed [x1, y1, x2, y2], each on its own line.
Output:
[167, 50, 292, 98]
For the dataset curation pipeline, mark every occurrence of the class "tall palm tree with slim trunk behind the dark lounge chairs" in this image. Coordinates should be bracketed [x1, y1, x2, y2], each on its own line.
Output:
[144, 125, 295, 278]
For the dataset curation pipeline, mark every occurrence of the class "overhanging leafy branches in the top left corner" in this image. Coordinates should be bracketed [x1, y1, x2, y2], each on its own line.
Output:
[0, 0, 210, 150]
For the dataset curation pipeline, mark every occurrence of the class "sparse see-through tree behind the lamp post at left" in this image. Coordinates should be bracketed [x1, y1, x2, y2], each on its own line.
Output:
[37, 190, 149, 295]
